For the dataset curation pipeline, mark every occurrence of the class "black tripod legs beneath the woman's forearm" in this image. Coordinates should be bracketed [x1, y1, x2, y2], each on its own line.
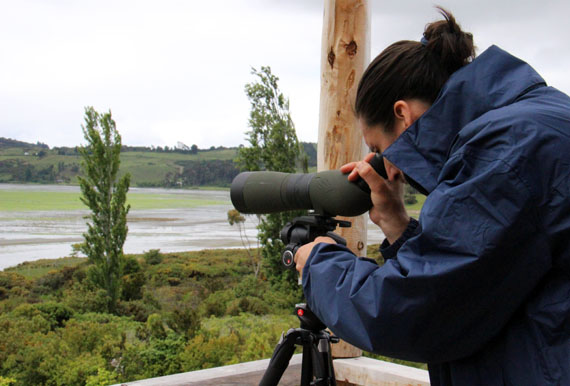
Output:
[259, 304, 338, 386]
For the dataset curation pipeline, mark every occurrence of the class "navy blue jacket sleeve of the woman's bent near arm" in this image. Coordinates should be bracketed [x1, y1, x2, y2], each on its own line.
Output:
[303, 155, 551, 363]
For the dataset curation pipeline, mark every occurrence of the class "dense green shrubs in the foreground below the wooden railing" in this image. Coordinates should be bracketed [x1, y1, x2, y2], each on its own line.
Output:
[0, 246, 424, 386]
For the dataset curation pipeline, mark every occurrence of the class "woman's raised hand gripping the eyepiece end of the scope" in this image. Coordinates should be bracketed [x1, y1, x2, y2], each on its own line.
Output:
[340, 153, 410, 244]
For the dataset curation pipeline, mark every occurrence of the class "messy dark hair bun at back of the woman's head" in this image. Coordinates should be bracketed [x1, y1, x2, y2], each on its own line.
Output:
[424, 7, 475, 75]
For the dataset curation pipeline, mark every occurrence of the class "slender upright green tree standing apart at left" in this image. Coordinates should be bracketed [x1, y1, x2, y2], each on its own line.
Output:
[78, 107, 130, 312]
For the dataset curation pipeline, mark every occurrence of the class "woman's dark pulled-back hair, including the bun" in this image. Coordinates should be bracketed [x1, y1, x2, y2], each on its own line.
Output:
[355, 7, 475, 130]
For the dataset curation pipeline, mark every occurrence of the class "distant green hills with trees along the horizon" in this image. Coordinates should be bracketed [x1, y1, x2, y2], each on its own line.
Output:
[0, 137, 316, 187]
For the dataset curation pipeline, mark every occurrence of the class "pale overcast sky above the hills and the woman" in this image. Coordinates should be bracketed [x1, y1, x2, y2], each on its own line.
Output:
[0, 0, 570, 148]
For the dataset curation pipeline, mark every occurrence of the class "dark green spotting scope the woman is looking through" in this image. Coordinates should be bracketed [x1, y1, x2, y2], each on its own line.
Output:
[230, 154, 386, 217]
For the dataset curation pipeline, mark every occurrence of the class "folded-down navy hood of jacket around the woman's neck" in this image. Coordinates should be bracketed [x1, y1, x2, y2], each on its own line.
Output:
[383, 46, 544, 193]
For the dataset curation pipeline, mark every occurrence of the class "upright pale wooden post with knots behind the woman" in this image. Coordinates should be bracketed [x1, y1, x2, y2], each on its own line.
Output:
[317, 0, 370, 358]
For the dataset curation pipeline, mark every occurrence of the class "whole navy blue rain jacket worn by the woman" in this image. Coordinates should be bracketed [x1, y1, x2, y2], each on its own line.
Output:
[303, 47, 570, 385]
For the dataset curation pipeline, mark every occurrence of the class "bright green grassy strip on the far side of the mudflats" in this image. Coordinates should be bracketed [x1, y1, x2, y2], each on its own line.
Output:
[0, 190, 228, 212]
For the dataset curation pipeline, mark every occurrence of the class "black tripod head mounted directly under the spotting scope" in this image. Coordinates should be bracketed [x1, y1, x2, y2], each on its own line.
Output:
[281, 215, 351, 269]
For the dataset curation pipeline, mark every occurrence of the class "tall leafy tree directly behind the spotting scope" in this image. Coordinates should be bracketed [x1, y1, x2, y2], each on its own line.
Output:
[238, 67, 306, 286]
